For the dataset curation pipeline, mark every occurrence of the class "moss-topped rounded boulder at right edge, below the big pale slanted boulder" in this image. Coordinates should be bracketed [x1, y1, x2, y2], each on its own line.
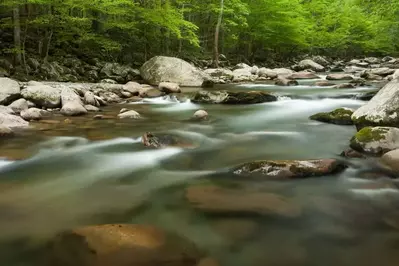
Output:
[350, 127, 399, 155]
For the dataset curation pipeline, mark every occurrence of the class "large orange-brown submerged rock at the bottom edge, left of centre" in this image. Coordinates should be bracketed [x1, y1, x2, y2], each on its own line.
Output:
[44, 224, 203, 266]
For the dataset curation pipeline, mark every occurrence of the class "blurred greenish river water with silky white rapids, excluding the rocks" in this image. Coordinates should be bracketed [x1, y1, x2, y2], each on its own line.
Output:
[0, 80, 399, 266]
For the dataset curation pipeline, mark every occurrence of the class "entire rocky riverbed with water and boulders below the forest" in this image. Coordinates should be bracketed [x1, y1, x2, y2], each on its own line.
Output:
[0, 55, 399, 266]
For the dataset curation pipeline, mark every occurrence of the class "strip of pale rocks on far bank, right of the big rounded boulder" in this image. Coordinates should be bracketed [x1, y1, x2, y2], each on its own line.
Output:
[204, 56, 399, 85]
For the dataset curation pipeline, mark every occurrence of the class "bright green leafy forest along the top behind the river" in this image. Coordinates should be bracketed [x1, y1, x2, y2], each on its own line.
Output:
[0, 0, 399, 65]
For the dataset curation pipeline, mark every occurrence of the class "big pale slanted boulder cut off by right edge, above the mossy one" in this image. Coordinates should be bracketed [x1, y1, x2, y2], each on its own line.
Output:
[352, 79, 399, 128]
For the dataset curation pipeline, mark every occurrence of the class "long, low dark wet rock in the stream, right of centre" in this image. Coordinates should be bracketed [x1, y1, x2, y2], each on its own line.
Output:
[233, 159, 346, 179]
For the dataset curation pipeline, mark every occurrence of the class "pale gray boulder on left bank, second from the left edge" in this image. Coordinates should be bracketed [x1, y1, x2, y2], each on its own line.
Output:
[21, 83, 61, 108]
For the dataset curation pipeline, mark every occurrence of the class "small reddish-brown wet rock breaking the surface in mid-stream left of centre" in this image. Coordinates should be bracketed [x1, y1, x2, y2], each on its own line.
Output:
[142, 132, 198, 149]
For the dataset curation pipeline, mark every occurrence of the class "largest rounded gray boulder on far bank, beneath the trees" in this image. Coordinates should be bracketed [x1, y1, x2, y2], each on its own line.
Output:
[140, 56, 210, 87]
